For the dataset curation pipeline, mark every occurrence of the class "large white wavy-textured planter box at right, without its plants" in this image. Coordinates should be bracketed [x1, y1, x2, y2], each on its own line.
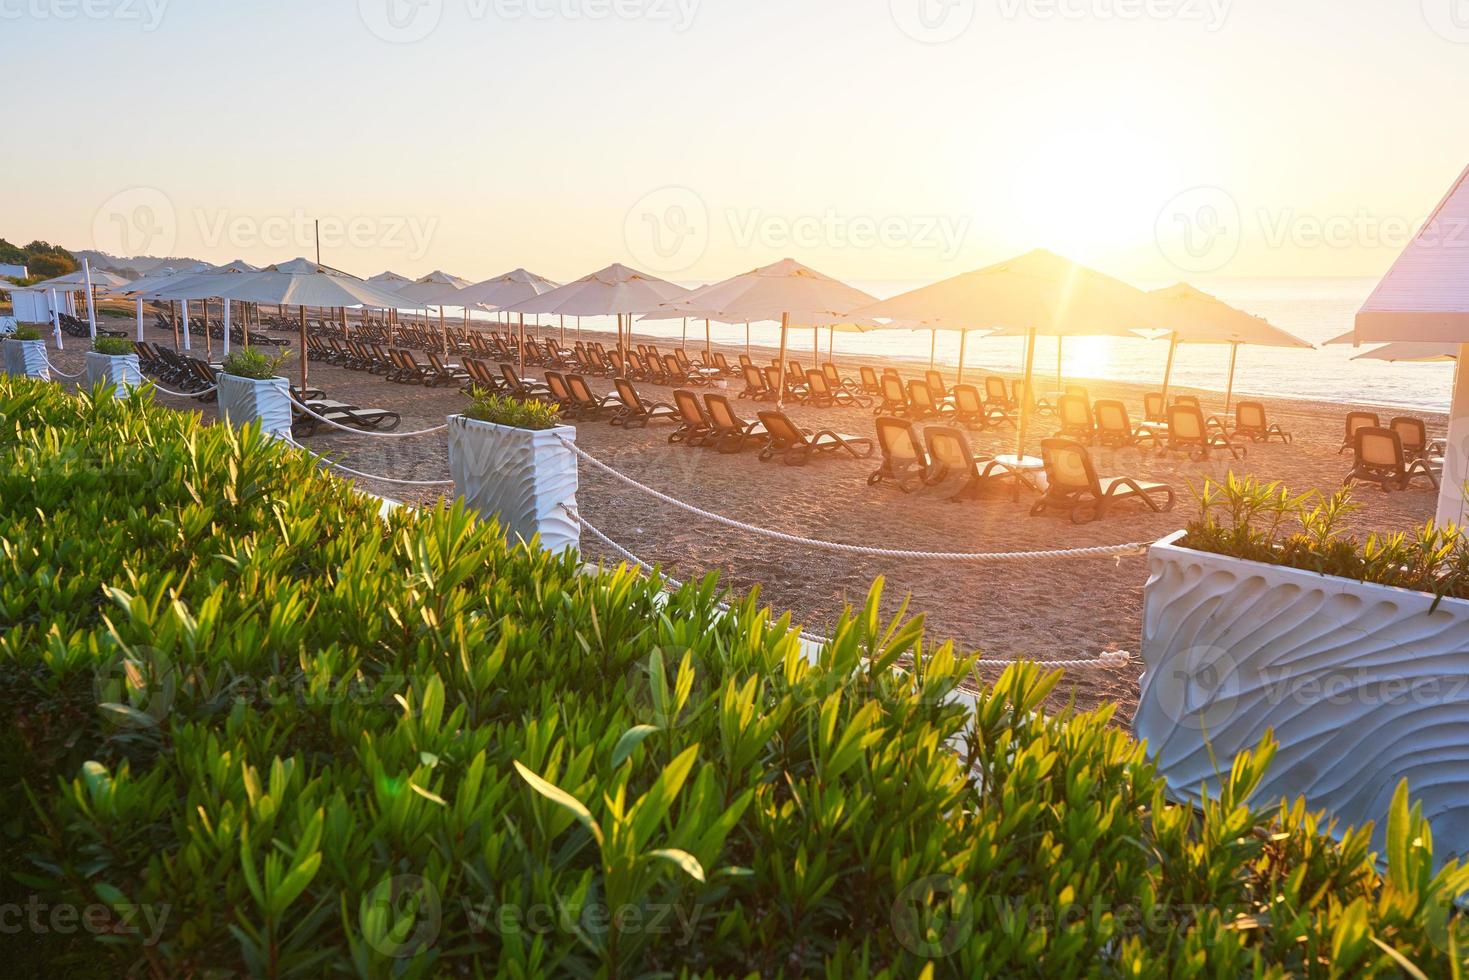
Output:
[1133, 532, 1469, 860]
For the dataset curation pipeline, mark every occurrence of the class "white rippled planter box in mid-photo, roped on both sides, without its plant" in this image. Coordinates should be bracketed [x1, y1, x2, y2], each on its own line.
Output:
[450, 416, 582, 551]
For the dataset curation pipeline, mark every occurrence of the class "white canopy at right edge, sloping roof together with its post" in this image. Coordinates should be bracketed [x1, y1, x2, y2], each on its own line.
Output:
[1356, 169, 1469, 525]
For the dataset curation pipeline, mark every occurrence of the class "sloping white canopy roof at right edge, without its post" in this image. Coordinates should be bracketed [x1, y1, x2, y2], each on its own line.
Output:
[1356, 161, 1469, 344]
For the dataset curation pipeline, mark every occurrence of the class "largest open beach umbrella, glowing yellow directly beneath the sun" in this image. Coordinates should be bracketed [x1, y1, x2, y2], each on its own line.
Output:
[856, 250, 1163, 457]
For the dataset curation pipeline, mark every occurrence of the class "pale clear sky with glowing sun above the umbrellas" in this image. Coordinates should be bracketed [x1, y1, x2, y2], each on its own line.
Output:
[0, 0, 1469, 282]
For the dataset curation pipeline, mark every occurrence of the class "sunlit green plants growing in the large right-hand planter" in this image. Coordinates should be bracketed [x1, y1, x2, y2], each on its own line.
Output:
[1178, 473, 1469, 599]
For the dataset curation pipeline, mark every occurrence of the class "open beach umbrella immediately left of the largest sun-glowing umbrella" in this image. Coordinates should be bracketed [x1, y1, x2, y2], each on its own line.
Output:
[665, 259, 874, 404]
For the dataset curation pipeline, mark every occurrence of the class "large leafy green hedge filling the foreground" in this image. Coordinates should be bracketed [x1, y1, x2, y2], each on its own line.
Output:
[0, 379, 1469, 977]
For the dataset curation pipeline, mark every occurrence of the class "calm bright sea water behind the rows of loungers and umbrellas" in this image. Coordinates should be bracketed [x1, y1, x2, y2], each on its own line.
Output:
[458, 279, 1454, 411]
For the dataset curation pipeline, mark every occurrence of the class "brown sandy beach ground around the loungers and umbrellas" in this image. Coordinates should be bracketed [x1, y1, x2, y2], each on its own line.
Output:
[40, 318, 1447, 721]
